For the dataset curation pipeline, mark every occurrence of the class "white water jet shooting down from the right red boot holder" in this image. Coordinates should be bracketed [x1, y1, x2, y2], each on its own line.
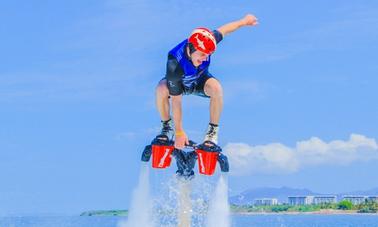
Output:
[206, 174, 231, 227]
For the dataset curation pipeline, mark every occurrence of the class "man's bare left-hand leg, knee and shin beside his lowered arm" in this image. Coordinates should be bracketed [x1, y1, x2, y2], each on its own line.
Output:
[156, 79, 170, 121]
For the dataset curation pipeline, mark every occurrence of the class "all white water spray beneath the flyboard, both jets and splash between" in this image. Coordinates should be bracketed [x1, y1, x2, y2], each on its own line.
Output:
[118, 160, 231, 227]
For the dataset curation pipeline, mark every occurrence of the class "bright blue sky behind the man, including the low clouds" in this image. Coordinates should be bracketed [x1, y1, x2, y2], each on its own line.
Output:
[0, 0, 378, 215]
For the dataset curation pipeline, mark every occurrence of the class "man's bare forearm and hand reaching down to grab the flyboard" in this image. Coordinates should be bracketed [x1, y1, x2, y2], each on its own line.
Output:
[171, 95, 188, 149]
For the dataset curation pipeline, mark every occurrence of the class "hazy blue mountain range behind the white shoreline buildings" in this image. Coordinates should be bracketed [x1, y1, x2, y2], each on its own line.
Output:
[230, 187, 378, 205]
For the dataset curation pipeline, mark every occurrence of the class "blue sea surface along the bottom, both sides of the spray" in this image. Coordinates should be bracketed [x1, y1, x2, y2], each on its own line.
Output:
[0, 214, 378, 227]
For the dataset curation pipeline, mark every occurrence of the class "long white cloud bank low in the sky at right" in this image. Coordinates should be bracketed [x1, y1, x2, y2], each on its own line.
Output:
[224, 134, 378, 175]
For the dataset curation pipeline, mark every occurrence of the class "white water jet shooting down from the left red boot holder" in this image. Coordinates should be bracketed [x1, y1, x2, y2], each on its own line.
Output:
[118, 163, 154, 227]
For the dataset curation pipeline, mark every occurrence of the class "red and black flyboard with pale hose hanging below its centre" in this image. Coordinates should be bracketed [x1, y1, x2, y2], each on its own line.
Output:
[141, 135, 230, 227]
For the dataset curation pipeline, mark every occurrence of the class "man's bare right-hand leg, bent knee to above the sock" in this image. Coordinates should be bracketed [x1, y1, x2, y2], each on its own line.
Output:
[204, 78, 223, 125]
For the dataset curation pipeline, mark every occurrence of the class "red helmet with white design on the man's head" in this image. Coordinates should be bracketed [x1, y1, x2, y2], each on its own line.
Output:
[188, 28, 217, 54]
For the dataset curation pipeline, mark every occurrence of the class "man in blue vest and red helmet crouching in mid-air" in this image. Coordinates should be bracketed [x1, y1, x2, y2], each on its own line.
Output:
[156, 14, 258, 149]
